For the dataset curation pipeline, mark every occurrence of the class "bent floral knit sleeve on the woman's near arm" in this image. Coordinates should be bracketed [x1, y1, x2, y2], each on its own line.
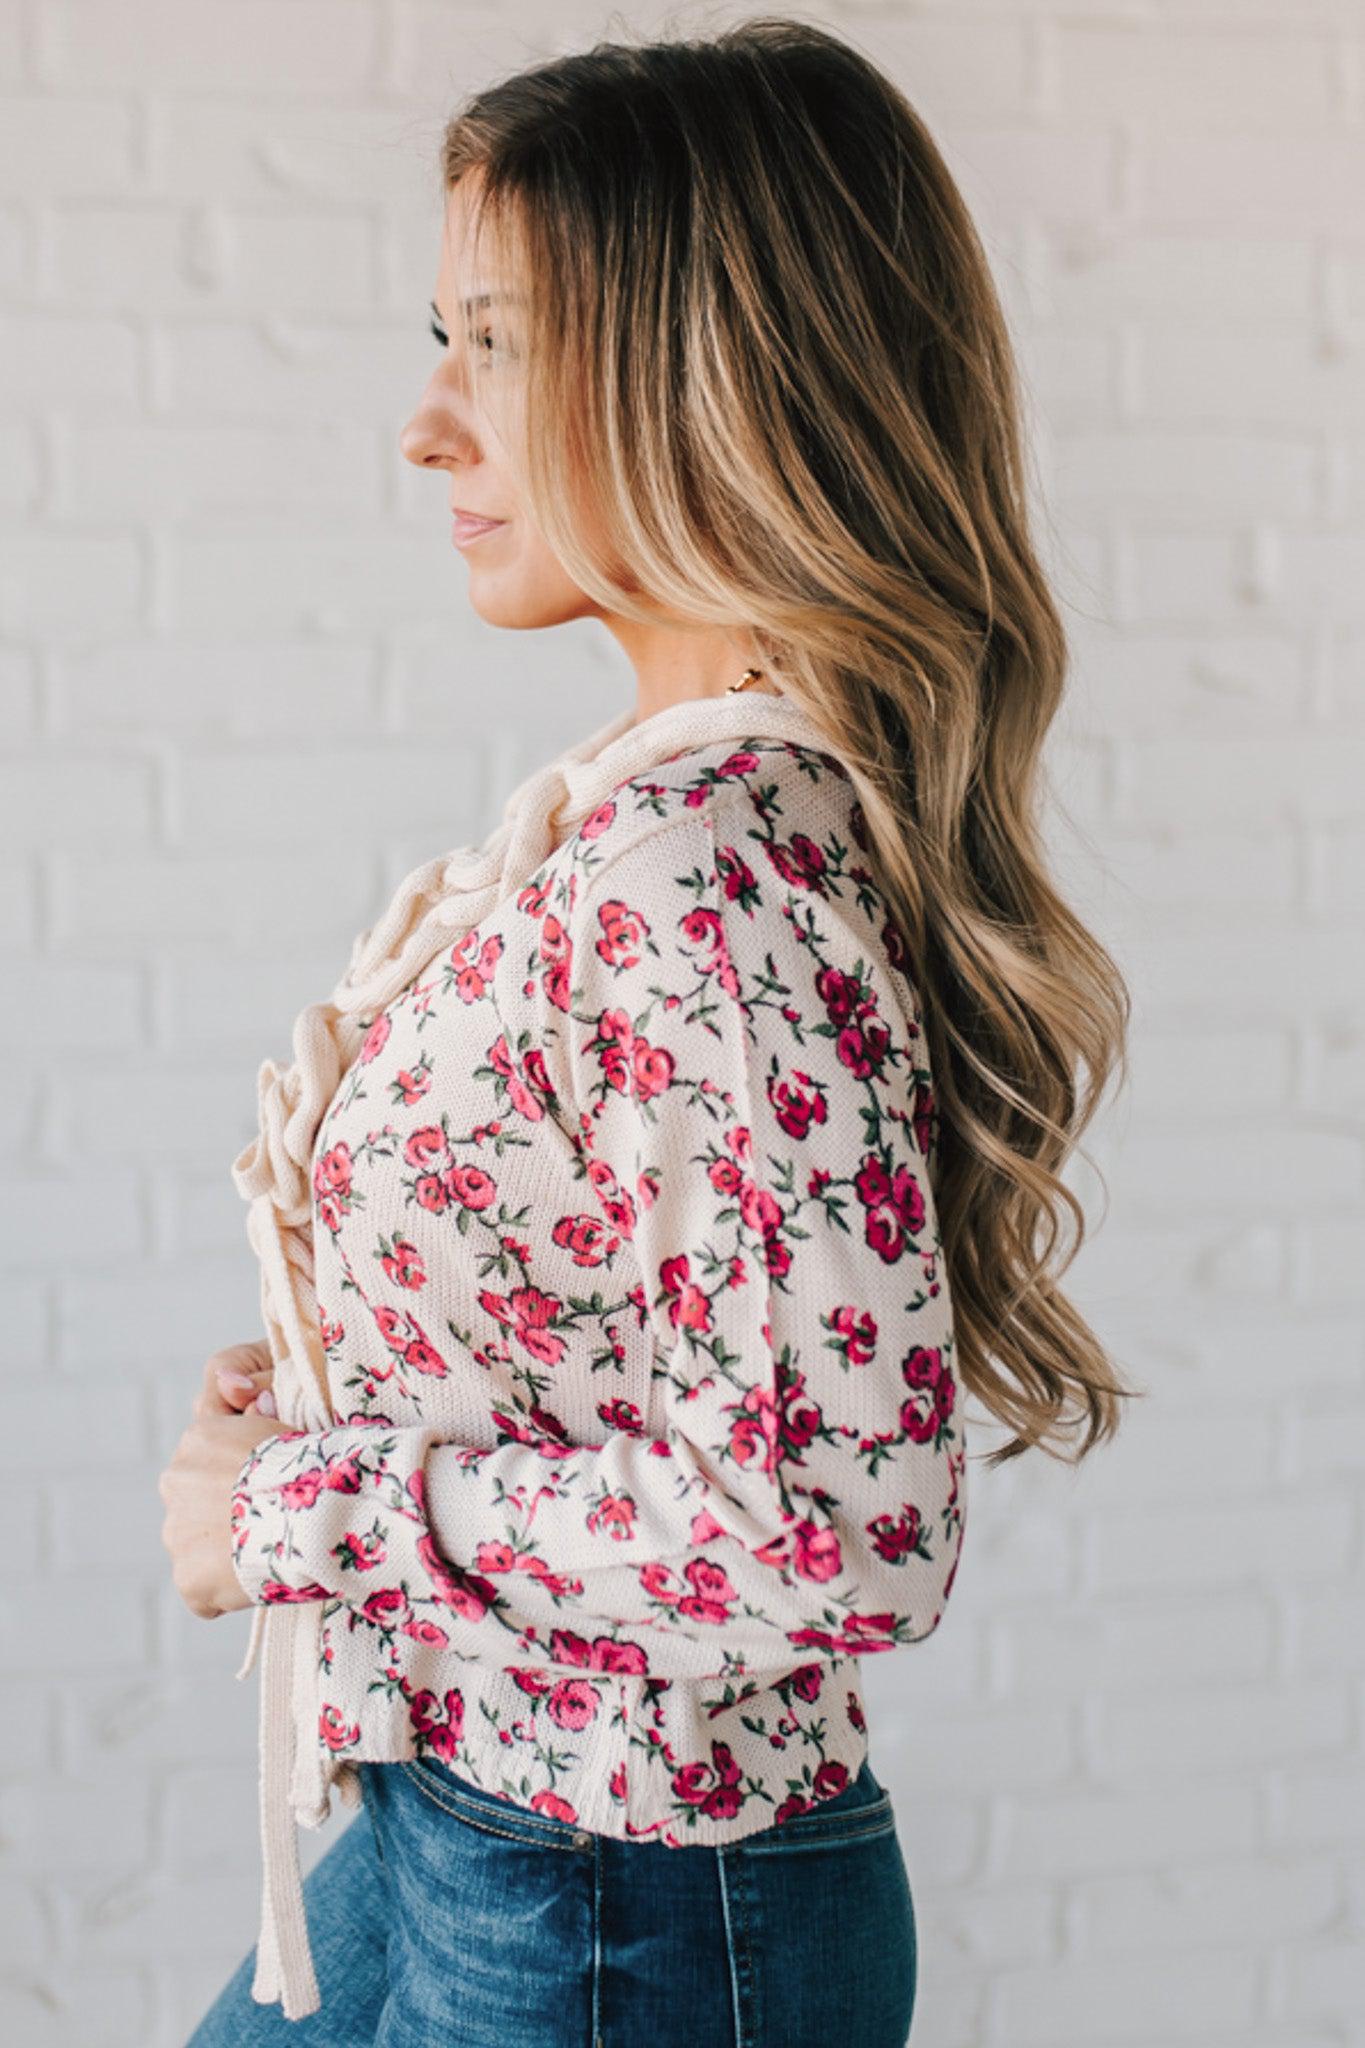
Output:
[233, 803, 964, 1677]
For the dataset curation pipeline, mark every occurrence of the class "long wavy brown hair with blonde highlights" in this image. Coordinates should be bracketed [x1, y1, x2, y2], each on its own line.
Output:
[440, 16, 1134, 1466]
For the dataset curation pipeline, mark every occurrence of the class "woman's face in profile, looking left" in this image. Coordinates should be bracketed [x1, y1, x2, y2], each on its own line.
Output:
[399, 178, 600, 627]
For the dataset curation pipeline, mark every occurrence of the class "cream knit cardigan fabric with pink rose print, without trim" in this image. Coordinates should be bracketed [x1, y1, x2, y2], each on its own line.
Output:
[231, 739, 966, 1847]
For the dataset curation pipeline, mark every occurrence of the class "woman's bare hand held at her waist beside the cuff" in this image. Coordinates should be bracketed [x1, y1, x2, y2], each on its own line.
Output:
[158, 1341, 284, 1620]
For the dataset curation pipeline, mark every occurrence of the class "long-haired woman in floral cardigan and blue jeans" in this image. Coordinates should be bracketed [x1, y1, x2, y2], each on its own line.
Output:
[162, 18, 1128, 2048]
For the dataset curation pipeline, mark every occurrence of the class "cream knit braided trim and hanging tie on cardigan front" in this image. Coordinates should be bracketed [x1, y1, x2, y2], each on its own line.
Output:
[233, 670, 833, 2019]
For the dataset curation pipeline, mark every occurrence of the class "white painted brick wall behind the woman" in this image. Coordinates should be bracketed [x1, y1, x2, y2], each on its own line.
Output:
[0, 0, 1365, 2048]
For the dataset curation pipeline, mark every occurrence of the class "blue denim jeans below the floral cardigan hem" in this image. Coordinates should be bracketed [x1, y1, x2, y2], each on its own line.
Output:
[186, 1761, 917, 2048]
